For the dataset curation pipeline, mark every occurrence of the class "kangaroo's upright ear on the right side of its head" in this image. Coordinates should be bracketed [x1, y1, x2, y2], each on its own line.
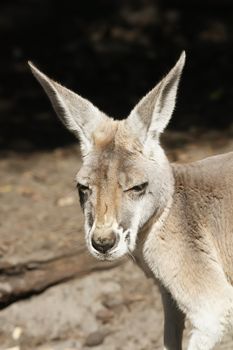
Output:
[126, 51, 185, 143]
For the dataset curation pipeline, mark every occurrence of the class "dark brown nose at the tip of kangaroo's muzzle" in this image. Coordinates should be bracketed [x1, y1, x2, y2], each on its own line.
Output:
[91, 231, 116, 254]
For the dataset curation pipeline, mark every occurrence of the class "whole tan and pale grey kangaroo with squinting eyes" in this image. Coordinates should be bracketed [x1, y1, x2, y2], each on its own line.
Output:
[29, 52, 233, 350]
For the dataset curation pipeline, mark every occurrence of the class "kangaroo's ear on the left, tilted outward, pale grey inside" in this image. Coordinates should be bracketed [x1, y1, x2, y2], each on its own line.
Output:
[28, 62, 107, 155]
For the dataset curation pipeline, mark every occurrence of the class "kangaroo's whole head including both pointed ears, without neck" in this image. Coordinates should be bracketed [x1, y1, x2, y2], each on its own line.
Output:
[30, 53, 185, 260]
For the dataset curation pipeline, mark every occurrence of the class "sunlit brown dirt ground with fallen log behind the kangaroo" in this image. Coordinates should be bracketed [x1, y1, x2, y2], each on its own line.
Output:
[0, 128, 233, 350]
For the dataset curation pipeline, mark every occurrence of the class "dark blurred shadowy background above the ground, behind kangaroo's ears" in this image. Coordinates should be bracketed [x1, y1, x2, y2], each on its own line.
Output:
[0, 0, 233, 151]
